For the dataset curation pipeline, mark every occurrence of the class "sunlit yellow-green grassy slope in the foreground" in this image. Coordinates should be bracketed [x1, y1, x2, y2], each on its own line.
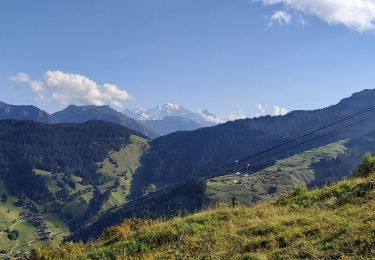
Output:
[33, 171, 375, 259]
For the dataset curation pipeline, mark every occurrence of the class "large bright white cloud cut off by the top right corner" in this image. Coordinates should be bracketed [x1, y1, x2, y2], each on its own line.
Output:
[262, 0, 375, 32]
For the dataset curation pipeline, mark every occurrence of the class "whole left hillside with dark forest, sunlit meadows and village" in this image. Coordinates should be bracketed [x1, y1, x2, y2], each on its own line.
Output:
[0, 121, 148, 253]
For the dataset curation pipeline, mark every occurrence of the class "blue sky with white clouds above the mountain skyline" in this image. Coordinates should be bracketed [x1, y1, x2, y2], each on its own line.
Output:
[0, 0, 375, 119]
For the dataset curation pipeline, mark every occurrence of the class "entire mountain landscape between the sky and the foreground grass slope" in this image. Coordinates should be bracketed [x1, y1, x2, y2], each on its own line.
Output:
[0, 90, 375, 254]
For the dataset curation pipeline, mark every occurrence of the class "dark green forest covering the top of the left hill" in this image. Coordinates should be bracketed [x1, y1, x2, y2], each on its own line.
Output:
[0, 120, 140, 200]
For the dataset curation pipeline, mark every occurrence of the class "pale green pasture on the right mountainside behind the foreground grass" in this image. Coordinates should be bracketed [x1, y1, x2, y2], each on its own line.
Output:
[206, 140, 346, 205]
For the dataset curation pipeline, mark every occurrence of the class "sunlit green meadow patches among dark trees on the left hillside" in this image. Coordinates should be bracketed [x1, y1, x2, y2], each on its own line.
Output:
[0, 136, 148, 253]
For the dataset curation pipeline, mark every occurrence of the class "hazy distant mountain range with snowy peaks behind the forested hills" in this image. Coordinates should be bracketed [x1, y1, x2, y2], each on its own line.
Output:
[0, 102, 222, 139]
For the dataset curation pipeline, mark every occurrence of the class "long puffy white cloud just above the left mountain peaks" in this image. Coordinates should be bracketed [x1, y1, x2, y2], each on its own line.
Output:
[11, 71, 131, 109]
